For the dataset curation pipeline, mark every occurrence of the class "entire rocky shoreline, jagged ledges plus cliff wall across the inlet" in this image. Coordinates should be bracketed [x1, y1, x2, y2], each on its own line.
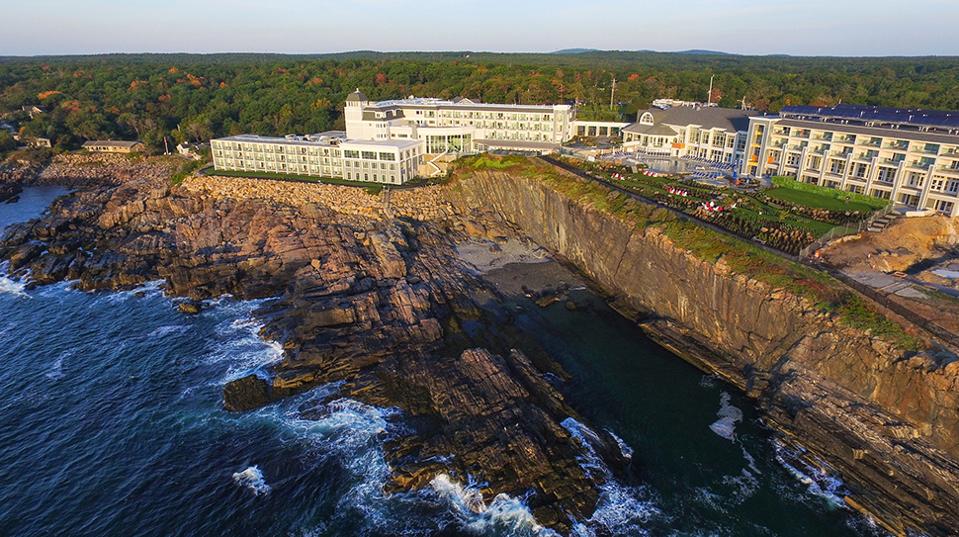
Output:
[0, 153, 959, 535]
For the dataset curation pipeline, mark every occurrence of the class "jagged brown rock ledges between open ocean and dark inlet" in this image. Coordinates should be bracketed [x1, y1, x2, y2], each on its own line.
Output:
[0, 155, 623, 531]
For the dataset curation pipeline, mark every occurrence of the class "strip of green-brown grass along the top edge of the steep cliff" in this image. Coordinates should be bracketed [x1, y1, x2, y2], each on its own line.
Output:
[456, 155, 925, 350]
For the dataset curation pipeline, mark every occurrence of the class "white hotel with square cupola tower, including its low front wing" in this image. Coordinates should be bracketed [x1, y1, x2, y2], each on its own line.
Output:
[211, 90, 576, 185]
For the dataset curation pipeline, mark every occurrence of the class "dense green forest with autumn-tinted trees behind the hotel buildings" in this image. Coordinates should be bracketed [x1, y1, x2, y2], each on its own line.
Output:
[0, 51, 959, 151]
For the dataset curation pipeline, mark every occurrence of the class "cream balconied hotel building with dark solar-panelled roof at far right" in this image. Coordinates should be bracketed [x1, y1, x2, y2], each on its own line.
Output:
[741, 105, 959, 216]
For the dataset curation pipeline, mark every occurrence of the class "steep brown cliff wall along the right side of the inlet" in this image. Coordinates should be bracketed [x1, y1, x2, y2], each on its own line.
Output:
[454, 164, 959, 535]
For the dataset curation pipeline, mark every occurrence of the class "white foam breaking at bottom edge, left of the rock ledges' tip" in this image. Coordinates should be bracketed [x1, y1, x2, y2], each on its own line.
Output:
[430, 474, 558, 537]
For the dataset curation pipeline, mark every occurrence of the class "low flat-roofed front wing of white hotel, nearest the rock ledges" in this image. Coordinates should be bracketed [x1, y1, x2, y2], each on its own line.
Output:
[210, 131, 423, 185]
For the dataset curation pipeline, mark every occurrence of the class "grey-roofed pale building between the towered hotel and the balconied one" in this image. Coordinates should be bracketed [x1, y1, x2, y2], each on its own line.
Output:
[623, 103, 758, 167]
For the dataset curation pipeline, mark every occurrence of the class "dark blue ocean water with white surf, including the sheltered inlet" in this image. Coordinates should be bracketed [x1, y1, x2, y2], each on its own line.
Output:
[0, 187, 880, 537]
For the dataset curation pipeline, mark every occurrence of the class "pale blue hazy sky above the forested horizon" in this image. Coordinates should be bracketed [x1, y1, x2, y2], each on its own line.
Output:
[0, 0, 959, 56]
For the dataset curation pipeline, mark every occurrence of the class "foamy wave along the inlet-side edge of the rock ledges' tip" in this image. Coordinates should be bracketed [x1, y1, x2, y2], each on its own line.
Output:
[562, 418, 662, 537]
